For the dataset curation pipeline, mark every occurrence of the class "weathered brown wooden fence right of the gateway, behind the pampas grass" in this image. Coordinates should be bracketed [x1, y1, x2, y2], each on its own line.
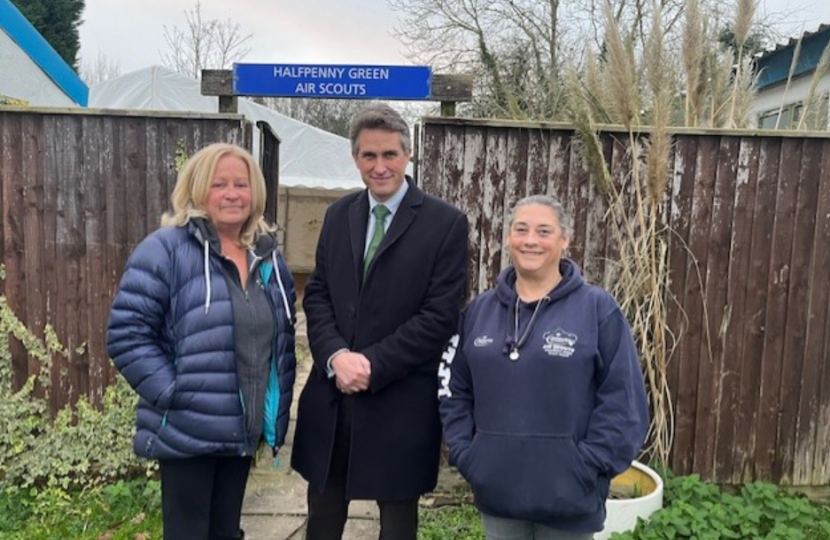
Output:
[419, 119, 830, 486]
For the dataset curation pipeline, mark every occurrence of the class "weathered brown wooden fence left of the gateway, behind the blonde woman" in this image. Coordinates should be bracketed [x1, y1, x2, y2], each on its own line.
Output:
[0, 108, 251, 411]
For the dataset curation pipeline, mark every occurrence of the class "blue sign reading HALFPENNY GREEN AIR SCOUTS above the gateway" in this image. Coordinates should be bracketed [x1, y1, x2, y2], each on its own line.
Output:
[233, 64, 432, 100]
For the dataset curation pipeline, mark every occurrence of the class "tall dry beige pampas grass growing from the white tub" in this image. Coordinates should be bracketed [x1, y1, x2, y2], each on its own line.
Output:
[567, 0, 688, 465]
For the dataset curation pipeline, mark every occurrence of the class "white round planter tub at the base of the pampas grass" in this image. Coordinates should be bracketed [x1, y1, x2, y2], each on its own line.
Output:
[594, 461, 663, 540]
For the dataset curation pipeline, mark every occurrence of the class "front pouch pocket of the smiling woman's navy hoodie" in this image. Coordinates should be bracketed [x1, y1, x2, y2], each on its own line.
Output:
[461, 431, 602, 521]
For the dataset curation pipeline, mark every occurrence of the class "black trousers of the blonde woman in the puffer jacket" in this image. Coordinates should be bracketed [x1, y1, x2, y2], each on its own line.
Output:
[159, 456, 251, 540]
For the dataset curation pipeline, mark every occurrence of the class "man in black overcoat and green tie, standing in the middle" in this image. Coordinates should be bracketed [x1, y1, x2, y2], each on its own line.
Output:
[291, 105, 467, 540]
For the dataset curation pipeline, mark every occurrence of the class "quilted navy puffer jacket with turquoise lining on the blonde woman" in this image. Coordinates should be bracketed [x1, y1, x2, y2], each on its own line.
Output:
[107, 222, 296, 459]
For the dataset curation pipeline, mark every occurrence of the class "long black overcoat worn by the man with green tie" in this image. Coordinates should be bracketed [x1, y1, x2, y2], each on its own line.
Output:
[291, 179, 467, 501]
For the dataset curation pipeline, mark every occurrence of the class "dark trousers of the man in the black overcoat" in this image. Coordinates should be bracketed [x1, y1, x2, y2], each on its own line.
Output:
[306, 397, 418, 540]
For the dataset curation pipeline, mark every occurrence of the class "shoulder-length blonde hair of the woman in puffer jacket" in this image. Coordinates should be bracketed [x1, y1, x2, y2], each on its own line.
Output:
[161, 143, 273, 247]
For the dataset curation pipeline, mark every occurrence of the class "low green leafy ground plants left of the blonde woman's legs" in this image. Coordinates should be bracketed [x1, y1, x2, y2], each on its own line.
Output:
[0, 479, 161, 540]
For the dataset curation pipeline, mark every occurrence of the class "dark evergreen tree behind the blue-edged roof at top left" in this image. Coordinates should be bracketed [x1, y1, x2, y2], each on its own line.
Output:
[12, 0, 84, 71]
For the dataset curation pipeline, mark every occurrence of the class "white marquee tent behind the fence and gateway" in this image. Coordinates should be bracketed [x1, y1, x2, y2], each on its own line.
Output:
[89, 66, 363, 189]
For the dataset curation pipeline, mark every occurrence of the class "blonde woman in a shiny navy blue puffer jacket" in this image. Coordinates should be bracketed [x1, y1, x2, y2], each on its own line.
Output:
[107, 143, 296, 540]
